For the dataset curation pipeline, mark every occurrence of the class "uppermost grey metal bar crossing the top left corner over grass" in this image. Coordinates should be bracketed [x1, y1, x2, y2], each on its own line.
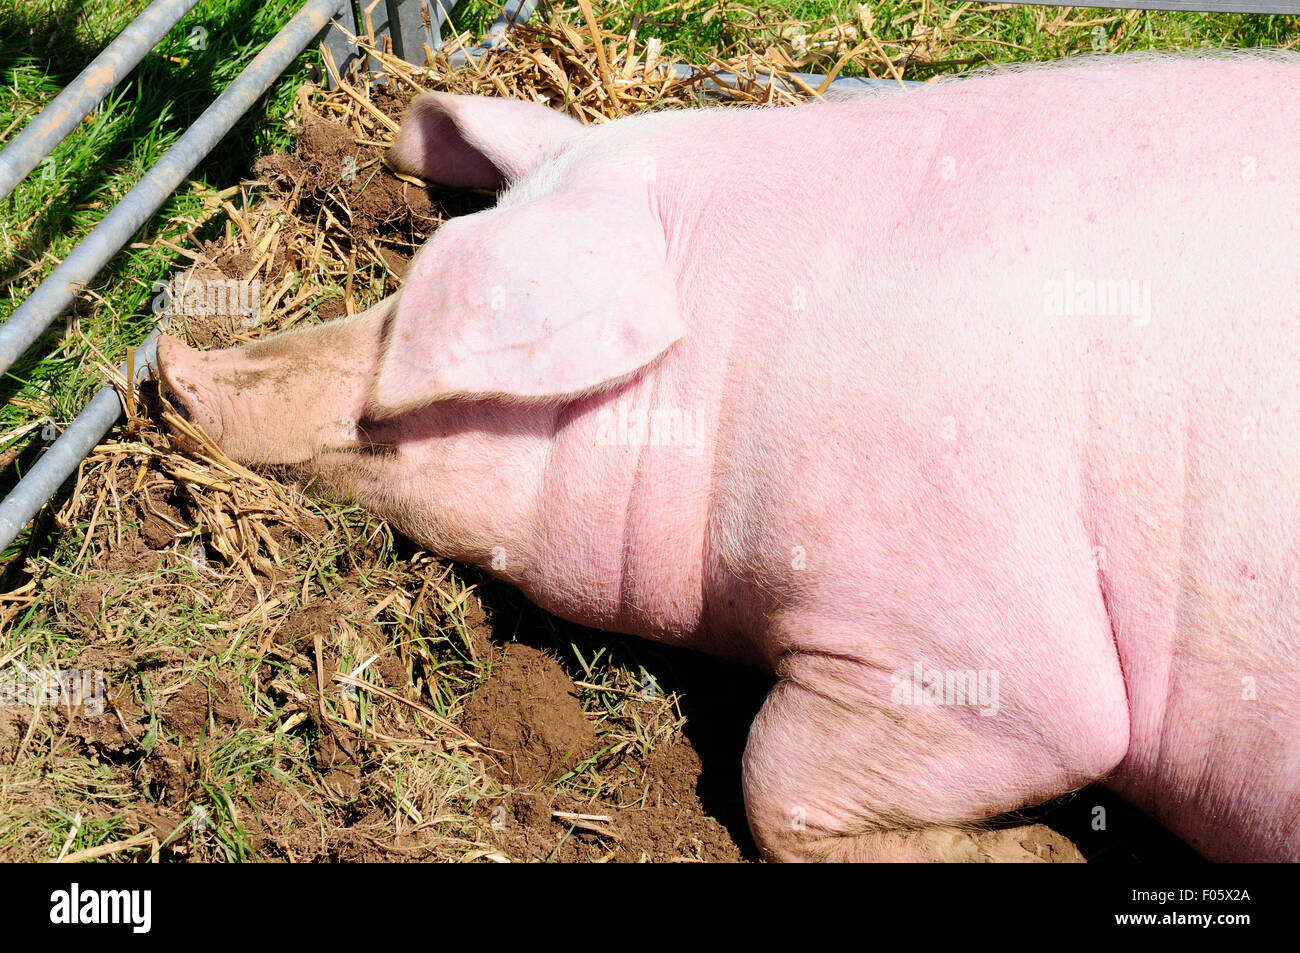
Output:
[0, 0, 199, 200]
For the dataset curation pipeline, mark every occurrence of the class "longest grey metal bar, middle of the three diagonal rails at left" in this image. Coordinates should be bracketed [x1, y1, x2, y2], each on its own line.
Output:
[0, 0, 343, 372]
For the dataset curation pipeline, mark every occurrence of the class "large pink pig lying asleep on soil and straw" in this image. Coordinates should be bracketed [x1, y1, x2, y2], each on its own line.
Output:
[159, 55, 1300, 861]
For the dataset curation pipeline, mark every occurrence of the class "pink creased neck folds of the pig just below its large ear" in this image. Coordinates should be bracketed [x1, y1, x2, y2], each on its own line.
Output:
[503, 371, 714, 641]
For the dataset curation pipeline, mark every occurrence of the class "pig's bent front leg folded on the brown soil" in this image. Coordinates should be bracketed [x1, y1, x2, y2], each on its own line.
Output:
[744, 608, 1128, 861]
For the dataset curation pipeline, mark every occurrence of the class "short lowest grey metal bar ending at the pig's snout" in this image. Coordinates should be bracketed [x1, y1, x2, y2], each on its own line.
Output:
[0, 324, 164, 553]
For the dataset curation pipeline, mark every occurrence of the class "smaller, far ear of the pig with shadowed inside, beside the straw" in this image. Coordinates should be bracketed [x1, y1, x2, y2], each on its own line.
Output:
[387, 92, 582, 189]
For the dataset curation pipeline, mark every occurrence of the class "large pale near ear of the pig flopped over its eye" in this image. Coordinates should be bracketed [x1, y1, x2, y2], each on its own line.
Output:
[371, 190, 686, 416]
